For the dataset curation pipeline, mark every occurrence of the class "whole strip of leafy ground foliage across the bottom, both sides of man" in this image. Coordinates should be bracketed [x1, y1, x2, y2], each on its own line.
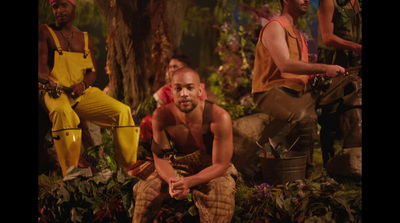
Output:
[38, 163, 362, 223]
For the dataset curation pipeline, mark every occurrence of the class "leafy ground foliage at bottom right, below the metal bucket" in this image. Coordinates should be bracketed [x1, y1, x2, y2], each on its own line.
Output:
[232, 175, 362, 223]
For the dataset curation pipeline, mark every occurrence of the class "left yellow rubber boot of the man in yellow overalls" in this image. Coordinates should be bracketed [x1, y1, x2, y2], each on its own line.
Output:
[52, 128, 82, 177]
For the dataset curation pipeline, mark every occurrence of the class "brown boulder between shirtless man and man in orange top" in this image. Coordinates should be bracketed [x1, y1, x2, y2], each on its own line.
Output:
[232, 113, 269, 179]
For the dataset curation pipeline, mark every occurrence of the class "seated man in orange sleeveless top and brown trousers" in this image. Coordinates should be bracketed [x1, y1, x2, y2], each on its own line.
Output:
[252, 0, 345, 178]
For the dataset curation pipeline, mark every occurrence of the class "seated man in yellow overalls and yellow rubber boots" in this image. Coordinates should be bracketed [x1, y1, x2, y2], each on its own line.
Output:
[38, 0, 140, 176]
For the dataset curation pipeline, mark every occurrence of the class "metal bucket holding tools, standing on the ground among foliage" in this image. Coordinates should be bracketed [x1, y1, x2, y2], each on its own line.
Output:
[259, 151, 307, 185]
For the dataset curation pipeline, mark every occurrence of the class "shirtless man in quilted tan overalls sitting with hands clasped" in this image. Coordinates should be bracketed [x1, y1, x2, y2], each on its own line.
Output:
[133, 67, 237, 222]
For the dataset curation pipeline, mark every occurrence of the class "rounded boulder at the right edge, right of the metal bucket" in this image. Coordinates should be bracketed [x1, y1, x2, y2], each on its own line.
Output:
[326, 147, 362, 182]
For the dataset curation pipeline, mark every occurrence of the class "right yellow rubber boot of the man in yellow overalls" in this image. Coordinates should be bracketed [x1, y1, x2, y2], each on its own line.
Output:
[114, 126, 140, 172]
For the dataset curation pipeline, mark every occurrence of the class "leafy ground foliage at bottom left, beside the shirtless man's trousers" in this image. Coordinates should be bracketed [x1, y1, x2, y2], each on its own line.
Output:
[38, 169, 139, 222]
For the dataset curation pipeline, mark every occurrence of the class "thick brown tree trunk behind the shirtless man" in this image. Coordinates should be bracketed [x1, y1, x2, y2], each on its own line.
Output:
[95, 0, 189, 108]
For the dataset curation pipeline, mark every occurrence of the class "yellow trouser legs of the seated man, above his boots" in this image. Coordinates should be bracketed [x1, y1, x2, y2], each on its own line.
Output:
[44, 87, 135, 131]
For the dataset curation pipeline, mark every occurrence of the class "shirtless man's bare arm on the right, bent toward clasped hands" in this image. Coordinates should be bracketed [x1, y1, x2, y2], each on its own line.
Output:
[172, 105, 233, 193]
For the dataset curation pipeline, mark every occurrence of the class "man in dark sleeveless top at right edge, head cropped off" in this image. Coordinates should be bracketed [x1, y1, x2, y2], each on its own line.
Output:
[317, 0, 362, 166]
